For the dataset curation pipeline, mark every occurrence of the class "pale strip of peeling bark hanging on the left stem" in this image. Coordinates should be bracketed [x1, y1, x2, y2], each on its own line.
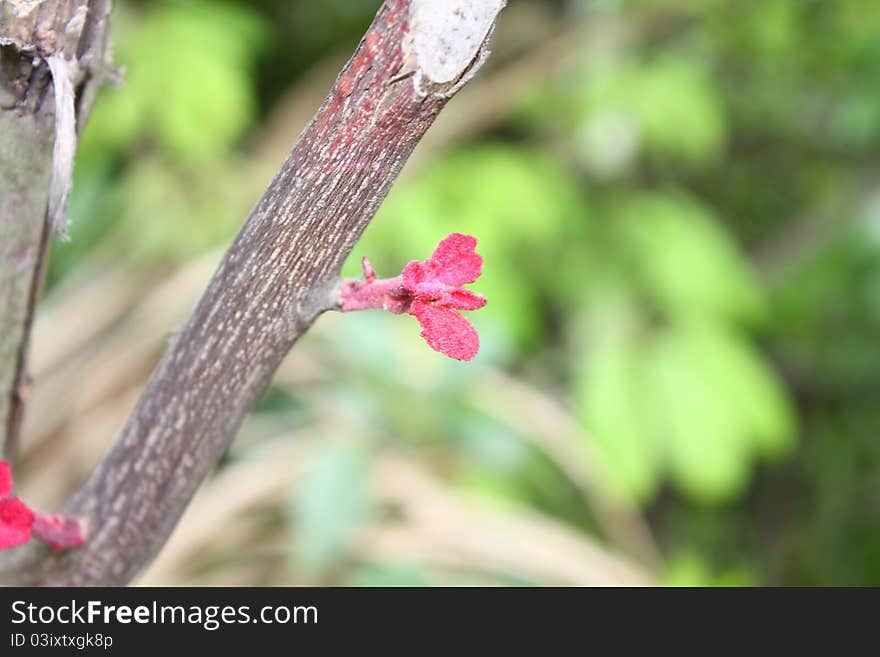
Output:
[46, 55, 77, 239]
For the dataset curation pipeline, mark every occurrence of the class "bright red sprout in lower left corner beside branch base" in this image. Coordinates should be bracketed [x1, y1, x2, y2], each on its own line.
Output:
[0, 461, 83, 550]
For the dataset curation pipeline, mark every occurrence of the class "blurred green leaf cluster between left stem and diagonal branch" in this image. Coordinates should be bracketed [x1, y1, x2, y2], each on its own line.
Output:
[83, 0, 267, 162]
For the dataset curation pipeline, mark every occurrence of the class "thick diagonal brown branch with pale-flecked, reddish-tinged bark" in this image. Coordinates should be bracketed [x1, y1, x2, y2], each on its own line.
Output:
[2, 0, 503, 585]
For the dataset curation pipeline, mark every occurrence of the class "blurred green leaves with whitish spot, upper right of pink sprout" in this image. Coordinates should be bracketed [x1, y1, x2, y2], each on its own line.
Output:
[522, 50, 728, 169]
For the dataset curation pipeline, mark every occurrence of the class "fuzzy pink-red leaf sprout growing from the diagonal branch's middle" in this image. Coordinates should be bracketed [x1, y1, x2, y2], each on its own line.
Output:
[340, 233, 486, 360]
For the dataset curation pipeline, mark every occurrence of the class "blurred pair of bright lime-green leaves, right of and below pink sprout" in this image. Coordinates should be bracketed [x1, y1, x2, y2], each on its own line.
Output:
[575, 297, 795, 502]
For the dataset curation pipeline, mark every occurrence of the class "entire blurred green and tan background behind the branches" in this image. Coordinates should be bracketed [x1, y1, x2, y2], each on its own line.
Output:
[17, 0, 880, 585]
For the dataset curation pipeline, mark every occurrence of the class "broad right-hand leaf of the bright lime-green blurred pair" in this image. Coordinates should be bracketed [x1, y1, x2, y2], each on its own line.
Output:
[648, 321, 794, 502]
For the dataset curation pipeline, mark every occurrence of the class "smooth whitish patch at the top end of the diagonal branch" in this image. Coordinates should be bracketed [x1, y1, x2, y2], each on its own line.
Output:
[410, 0, 507, 95]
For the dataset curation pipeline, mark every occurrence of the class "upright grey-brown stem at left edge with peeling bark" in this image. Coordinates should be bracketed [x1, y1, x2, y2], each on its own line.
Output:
[0, 0, 110, 457]
